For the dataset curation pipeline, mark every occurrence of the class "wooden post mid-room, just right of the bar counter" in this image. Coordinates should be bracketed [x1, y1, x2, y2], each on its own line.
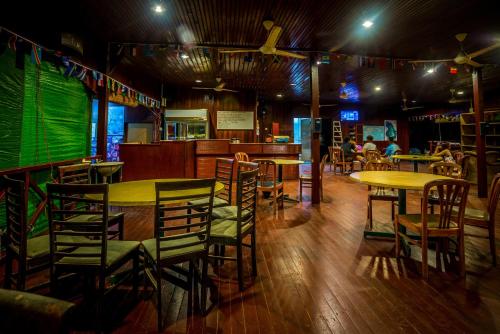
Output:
[309, 55, 321, 204]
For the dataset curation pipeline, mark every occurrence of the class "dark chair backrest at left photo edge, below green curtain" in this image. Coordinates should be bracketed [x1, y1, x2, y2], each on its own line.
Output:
[4, 176, 28, 259]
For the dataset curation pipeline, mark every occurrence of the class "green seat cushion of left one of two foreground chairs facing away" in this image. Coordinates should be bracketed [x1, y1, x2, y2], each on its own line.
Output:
[57, 240, 141, 267]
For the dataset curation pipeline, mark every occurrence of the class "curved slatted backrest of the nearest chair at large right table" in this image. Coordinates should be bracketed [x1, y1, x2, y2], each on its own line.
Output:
[422, 179, 470, 229]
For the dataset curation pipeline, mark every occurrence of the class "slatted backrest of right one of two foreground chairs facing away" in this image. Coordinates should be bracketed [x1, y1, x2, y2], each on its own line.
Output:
[154, 178, 215, 263]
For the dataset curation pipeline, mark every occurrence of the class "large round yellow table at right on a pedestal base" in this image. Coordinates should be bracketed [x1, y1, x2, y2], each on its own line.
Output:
[349, 171, 453, 237]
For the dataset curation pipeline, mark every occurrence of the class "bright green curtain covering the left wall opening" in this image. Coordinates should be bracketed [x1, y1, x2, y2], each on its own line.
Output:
[0, 49, 92, 234]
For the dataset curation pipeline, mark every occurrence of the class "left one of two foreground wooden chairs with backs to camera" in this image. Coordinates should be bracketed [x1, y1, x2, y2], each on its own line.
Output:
[47, 183, 140, 327]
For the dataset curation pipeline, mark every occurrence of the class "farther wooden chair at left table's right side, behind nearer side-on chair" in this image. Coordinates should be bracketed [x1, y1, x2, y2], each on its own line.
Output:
[191, 158, 234, 208]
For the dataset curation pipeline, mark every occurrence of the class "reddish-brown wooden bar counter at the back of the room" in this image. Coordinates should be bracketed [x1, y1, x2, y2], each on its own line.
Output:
[120, 139, 302, 181]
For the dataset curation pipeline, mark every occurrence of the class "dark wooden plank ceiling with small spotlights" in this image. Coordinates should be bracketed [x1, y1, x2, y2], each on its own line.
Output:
[4, 0, 500, 103]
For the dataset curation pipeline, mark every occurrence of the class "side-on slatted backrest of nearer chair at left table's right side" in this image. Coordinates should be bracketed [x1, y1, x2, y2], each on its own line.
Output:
[236, 164, 259, 237]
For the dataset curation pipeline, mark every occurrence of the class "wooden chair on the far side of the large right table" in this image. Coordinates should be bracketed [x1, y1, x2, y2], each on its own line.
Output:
[365, 159, 398, 230]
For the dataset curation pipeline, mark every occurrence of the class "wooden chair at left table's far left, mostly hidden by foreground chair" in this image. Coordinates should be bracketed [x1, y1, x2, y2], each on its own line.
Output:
[58, 163, 125, 240]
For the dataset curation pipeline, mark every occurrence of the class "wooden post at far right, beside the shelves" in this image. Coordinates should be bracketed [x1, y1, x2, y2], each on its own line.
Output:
[472, 68, 488, 198]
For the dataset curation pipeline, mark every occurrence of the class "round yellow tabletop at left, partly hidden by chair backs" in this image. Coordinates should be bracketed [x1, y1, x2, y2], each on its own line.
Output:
[96, 179, 224, 206]
